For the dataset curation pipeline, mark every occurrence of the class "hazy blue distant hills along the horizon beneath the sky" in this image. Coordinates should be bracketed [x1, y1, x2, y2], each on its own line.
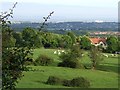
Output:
[11, 22, 118, 31]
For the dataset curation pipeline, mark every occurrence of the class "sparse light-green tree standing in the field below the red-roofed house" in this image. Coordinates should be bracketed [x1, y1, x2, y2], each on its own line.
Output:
[90, 46, 103, 69]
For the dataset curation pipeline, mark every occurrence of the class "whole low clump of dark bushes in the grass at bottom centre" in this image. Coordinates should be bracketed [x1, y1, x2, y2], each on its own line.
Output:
[46, 76, 90, 88]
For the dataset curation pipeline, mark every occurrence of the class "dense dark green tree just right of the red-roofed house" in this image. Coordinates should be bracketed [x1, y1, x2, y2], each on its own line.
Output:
[106, 36, 119, 53]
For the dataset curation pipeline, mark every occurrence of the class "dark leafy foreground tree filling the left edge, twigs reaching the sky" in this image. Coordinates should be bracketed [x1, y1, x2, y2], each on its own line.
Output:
[0, 3, 31, 90]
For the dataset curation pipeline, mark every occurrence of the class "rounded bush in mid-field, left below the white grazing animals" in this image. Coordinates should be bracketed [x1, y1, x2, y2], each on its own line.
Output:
[34, 55, 53, 66]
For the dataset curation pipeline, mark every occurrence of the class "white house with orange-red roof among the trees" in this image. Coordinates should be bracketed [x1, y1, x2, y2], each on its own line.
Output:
[90, 38, 107, 49]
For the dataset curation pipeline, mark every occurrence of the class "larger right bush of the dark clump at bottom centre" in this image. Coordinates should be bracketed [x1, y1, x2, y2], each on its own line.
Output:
[70, 77, 90, 88]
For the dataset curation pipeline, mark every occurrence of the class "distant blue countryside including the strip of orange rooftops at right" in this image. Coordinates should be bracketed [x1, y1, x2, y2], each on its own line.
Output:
[11, 21, 120, 36]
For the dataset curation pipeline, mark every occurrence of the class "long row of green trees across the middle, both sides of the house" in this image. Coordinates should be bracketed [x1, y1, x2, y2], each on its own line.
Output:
[9, 27, 120, 53]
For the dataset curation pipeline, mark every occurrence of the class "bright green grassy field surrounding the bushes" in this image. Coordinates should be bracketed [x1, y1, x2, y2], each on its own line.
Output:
[16, 48, 118, 88]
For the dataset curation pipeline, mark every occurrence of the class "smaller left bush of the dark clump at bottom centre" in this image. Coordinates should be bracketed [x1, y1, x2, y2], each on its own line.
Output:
[46, 76, 63, 85]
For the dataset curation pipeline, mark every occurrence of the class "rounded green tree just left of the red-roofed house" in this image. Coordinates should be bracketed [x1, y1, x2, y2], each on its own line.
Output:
[80, 36, 91, 50]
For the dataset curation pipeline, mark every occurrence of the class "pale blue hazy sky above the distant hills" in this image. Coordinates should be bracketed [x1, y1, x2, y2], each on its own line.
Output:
[0, 0, 119, 22]
